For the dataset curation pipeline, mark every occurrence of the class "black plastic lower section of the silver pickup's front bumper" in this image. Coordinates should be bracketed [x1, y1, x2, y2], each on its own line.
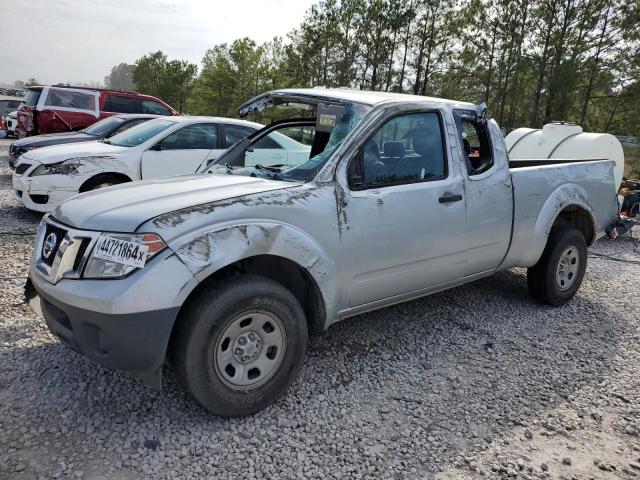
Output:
[36, 280, 179, 388]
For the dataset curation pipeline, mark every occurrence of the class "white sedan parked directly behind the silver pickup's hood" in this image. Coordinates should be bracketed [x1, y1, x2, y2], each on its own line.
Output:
[13, 117, 310, 212]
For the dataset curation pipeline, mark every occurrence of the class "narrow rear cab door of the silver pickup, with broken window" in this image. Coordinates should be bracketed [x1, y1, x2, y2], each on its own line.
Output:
[454, 110, 512, 275]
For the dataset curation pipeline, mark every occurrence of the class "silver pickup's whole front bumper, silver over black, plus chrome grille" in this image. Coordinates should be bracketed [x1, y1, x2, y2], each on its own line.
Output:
[29, 217, 198, 387]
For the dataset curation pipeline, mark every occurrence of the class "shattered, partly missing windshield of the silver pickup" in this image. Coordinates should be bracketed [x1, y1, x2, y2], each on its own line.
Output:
[210, 103, 371, 182]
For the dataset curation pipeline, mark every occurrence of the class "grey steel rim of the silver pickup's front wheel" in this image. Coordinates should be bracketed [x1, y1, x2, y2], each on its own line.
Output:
[213, 311, 287, 391]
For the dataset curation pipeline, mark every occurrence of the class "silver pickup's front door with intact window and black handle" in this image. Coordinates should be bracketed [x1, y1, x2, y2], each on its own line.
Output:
[336, 110, 467, 307]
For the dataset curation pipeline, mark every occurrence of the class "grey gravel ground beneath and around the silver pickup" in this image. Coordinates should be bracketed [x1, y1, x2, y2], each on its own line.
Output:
[0, 136, 640, 480]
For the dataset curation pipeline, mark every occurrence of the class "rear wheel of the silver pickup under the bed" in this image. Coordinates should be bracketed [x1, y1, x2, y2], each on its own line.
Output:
[527, 227, 587, 306]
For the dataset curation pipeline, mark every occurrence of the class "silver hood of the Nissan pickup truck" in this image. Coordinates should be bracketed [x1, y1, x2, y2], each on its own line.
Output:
[53, 174, 298, 232]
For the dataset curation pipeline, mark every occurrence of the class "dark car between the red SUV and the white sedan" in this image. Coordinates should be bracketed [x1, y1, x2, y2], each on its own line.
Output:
[9, 114, 160, 169]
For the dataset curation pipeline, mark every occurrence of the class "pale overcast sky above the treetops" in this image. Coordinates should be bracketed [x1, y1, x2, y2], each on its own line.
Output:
[0, 0, 314, 84]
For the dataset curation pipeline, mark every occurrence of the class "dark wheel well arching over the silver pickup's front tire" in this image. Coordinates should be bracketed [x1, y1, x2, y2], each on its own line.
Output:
[178, 255, 326, 335]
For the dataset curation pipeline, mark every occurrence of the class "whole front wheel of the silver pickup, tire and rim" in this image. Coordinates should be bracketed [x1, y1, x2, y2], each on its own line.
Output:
[172, 275, 308, 417]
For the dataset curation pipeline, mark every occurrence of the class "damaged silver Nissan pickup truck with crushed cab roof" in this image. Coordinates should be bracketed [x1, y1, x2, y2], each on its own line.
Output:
[30, 89, 618, 416]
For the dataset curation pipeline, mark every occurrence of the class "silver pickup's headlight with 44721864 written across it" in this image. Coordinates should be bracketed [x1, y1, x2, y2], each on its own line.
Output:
[83, 233, 167, 278]
